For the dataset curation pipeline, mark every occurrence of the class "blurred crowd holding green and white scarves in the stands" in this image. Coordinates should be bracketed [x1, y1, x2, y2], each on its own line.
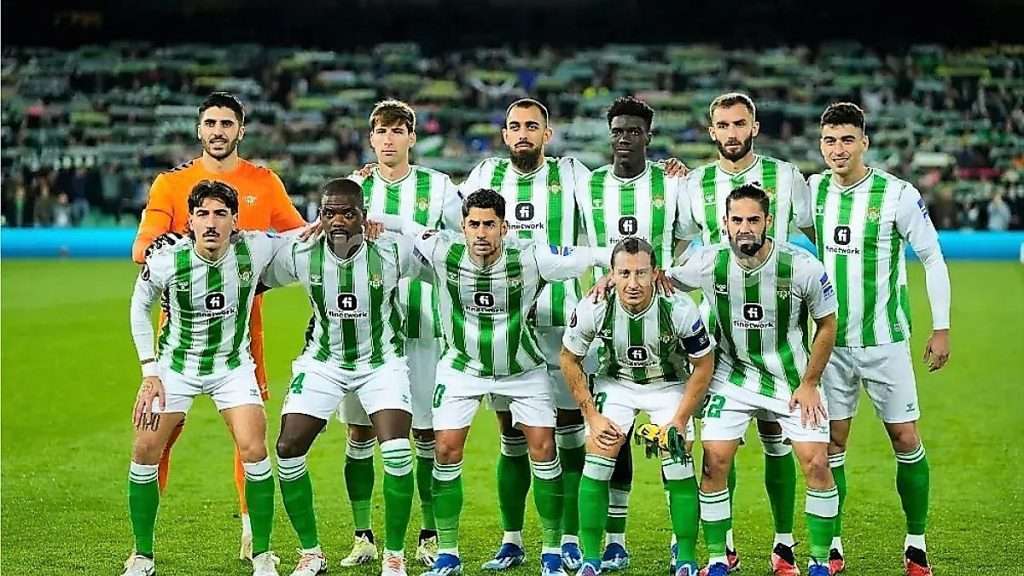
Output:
[0, 43, 1024, 230]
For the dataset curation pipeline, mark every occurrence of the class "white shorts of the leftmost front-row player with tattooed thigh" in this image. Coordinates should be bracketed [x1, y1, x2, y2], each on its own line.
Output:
[153, 365, 263, 414]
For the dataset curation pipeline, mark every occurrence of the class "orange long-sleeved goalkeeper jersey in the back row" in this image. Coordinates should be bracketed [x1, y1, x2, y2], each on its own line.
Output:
[132, 158, 306, 263]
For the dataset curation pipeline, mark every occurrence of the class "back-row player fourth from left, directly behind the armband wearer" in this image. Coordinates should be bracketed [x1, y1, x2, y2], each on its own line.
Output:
[575, 96, 684, 572]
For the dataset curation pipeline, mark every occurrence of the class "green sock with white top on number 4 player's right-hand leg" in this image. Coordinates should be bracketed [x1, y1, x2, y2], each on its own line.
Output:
[381, 438, 416, 552]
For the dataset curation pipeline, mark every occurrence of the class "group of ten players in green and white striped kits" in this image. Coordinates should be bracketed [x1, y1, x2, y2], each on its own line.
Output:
[119, 93, 949, 576]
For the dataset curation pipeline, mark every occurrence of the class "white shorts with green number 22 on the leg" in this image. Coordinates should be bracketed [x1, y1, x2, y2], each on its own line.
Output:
[700, 374, 828, 444]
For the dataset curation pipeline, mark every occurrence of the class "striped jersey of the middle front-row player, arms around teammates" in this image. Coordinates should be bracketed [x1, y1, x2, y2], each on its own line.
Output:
[403, 224, 611, 377]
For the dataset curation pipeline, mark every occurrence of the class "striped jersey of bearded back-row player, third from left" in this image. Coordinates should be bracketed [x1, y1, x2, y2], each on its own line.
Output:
[459, 158, 587, 326]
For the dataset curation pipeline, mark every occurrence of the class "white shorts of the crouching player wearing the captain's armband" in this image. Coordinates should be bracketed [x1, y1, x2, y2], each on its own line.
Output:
[588, 376, 693, 432]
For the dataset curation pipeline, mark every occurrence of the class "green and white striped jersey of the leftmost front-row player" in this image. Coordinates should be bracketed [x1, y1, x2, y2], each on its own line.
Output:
[131, 232, 292, 376]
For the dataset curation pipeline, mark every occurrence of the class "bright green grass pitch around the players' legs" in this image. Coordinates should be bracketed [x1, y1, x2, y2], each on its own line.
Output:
[0, 260, 1024, 576]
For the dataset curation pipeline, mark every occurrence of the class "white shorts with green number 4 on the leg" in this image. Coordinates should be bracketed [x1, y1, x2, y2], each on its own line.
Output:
[281, 358, 413, 425]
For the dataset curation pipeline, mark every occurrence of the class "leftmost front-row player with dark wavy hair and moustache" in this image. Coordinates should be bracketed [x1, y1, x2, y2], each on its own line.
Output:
[124, 180, 290, 576]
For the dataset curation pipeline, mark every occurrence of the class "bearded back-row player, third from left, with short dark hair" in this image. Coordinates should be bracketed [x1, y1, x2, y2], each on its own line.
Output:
[461, 98, 588, 570]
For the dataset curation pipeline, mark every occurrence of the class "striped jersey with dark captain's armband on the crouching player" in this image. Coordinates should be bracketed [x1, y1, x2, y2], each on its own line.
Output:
[562, 292, 715, 384]
